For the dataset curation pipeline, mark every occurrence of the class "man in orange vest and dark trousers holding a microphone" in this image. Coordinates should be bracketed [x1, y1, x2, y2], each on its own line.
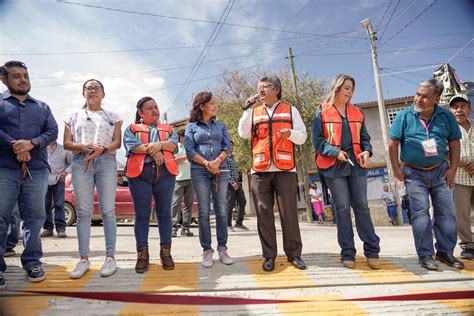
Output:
[239, 76, 307, 272]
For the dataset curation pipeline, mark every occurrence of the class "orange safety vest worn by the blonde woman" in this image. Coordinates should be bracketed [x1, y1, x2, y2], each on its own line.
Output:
[316, 104, 364, 169]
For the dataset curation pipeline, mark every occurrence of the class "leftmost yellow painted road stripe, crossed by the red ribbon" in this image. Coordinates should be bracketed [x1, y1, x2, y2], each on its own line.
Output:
[0, 264, 99, 316]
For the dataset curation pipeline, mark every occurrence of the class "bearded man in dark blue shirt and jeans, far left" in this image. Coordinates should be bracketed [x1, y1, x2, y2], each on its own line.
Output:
[0, 61, 58, 288]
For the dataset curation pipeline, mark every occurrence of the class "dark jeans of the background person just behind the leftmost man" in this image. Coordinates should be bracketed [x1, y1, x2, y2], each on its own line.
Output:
[43, 181, 66, 233]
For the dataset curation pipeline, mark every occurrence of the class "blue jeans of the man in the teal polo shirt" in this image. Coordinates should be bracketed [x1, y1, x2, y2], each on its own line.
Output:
[402, 161, 457, 256]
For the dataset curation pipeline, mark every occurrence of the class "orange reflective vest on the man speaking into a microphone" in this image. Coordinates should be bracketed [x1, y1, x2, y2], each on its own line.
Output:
[252, 102, 295, 172]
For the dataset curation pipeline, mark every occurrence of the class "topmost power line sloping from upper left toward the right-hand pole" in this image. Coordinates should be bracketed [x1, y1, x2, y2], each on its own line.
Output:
[56, 0, 358, 38]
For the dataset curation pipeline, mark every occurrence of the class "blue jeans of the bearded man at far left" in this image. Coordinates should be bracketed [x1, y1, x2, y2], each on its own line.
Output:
[0, 167, 48, 272]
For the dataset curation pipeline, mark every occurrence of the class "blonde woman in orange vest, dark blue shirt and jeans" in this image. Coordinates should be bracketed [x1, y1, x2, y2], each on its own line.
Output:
[313, 74, 380, 269]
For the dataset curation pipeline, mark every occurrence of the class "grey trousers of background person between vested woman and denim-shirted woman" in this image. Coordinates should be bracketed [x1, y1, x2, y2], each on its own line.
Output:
[171, 180, 194, 228]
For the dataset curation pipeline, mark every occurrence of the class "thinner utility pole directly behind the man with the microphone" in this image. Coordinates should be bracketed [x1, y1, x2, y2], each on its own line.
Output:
[288, 47, 313, 223]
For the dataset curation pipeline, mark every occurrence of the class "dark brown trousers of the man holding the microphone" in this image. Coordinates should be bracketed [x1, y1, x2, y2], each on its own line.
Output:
[252, 171, 303, 258]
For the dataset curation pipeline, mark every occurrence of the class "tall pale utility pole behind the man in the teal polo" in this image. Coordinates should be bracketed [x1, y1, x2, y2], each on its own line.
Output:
[360, 18, 403, 224]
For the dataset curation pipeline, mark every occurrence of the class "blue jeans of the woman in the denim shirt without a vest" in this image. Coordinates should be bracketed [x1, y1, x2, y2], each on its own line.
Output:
[191, 168, 230, 251]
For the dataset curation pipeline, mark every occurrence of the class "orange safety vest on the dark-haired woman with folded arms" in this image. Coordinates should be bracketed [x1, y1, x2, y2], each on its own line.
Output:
[125, 124, 179, 178]
